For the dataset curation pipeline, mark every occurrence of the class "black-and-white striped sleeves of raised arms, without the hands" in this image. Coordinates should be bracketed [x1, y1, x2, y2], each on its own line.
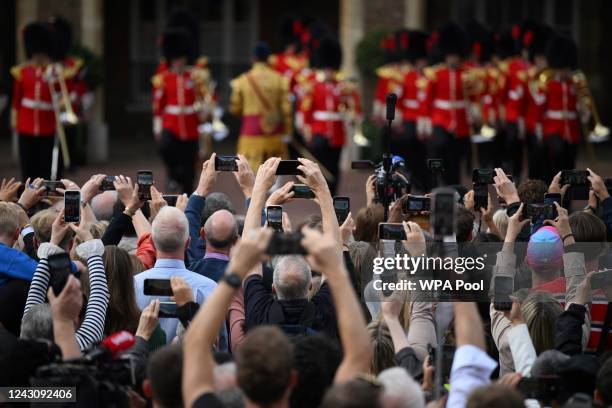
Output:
[23, 255, 110, 351]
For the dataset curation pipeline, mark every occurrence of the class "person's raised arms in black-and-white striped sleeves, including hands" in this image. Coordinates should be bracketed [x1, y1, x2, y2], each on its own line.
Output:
[24, 211, 109, 350]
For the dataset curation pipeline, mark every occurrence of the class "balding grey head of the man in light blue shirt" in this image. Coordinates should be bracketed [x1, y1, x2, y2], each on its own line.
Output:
[151, 206, 189, 252]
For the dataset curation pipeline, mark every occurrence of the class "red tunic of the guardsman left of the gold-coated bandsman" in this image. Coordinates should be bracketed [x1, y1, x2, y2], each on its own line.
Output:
[153, 68, 200, 141]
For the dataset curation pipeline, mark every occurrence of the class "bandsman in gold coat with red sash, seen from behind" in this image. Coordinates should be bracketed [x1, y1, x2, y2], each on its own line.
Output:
[229, 43, 293, 170]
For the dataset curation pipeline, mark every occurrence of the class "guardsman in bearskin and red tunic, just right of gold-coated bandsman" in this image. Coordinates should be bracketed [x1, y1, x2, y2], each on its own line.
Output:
[300, 37, 354, 195]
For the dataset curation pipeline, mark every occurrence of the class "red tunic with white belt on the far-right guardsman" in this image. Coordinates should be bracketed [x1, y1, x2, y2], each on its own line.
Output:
[542, 76, 580, 144]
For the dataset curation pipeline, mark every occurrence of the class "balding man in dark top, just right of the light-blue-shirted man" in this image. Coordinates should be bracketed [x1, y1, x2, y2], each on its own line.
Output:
[189, 210, 238, 282]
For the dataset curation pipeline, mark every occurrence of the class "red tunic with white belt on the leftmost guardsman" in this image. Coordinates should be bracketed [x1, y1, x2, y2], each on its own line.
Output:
[11, 64, 55, 137]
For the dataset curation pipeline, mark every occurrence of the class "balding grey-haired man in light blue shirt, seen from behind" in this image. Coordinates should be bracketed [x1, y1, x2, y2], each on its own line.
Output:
[134, 206, 227, 350]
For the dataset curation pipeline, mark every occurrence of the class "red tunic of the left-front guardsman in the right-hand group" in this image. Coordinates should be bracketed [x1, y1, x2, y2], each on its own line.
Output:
[425, 65, 470, 137]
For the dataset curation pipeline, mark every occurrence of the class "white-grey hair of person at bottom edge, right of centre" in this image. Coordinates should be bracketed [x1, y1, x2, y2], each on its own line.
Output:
[378, 367, 425, 408]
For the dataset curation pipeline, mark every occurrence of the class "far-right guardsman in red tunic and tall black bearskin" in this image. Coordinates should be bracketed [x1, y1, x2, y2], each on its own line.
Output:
[540, 35, 580, 180]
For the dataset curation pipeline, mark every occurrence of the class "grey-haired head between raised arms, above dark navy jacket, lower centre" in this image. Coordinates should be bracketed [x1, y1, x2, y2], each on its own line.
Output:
[273, 255, 312, 300]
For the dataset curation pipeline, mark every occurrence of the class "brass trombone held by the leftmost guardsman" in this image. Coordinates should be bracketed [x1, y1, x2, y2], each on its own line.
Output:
[45, 63, 74, 180]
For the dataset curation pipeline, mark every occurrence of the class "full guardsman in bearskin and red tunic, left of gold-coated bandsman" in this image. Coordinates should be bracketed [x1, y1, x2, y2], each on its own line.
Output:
[152, 28, 200, 193]
